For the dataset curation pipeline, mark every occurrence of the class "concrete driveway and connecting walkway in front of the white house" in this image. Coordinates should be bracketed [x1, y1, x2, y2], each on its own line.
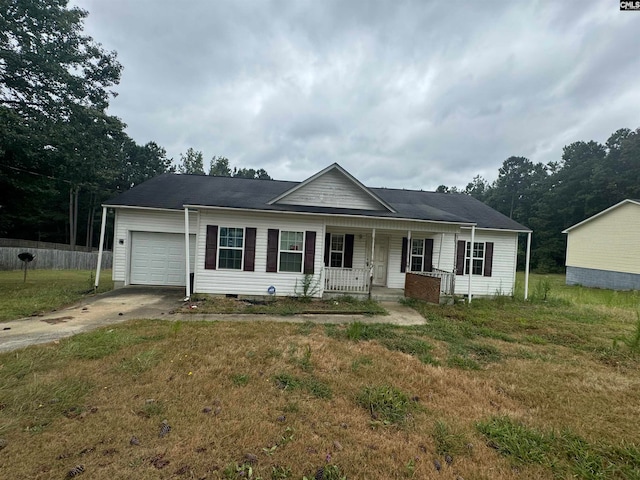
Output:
[0, 287, 425, 352]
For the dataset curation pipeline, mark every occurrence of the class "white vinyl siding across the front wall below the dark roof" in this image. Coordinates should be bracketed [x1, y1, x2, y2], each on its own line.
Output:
[113, 208, 520, 296]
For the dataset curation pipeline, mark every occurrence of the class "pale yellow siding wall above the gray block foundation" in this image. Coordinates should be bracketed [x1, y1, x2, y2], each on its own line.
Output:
[566, 203, 640, 274]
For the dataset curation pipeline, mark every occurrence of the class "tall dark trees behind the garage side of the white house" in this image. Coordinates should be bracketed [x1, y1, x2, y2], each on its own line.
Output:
[0, 0, 269, 251]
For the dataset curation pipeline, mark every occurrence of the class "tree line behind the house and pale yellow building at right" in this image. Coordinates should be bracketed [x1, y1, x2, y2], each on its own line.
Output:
[437, 128, 640, 272]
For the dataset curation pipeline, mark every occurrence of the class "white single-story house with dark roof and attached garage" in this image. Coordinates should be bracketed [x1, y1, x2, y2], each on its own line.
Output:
[98, 164, 531, 296]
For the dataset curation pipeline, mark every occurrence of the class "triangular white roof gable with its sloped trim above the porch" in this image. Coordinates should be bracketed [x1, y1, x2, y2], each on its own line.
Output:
[269, 163, 395, 213]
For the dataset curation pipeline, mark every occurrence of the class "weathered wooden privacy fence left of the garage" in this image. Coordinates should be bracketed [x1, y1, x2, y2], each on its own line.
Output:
[0, 247, 113, 270]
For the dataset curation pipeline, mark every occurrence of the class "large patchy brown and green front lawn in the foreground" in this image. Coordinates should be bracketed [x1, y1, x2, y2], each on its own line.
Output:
[0, 276, 640, 480]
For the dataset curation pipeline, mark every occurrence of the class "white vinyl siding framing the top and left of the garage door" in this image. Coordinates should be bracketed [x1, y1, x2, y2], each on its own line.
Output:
[112, 208, 197, 285]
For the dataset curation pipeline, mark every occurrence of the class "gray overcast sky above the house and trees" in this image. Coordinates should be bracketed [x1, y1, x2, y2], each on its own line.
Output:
[74, 0, 640, 190]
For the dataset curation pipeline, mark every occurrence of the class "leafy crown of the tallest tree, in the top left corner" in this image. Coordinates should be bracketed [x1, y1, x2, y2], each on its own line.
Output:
[0, 0, 122, 114]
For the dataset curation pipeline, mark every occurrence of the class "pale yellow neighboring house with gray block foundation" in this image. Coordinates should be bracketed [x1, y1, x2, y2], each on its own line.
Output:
[562, 200, 640, 290]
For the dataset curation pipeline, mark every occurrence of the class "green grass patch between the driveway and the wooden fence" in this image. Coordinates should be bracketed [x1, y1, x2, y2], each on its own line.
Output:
[0, 270, 113, 321]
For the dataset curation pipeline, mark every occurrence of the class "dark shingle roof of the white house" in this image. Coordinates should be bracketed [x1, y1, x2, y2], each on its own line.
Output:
[105, 173, 529, 231]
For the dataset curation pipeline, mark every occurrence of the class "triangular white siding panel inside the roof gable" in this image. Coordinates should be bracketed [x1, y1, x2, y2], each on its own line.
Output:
[277, 170, 386, 210]
